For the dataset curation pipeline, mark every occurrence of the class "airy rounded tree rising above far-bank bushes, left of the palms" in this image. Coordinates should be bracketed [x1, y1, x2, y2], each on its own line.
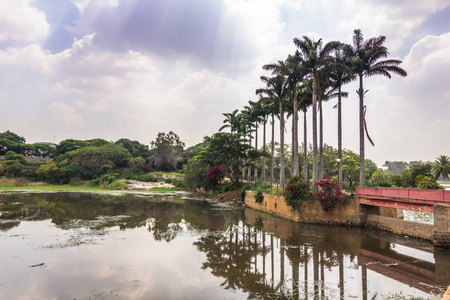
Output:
[150, 131, 185, 170]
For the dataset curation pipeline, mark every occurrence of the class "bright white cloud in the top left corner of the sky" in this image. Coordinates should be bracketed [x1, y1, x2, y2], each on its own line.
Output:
[0, 0, 50, 42]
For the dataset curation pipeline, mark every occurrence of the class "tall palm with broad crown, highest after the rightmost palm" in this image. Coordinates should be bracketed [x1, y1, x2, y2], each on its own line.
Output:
[294, 36, 339, 190]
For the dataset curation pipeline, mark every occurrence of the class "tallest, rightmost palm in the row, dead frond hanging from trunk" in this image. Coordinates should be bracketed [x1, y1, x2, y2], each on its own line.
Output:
[344, 29, 407, 186]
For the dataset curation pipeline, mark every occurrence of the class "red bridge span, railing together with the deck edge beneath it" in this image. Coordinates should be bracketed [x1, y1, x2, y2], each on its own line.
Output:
[356, 187, 450, 212]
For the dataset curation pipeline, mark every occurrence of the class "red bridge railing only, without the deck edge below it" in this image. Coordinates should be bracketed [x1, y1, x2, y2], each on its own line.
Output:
[356, 187, 450, 205]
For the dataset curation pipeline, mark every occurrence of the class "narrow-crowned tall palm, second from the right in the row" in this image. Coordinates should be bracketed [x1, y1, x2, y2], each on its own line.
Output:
[330, 48, 355, 188]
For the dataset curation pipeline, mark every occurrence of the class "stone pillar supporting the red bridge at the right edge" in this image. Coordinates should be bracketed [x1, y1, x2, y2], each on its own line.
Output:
[433, 205, 450, 248]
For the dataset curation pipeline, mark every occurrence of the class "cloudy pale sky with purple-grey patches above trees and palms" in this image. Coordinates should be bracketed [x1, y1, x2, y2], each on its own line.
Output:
[0, 0, 450, 167]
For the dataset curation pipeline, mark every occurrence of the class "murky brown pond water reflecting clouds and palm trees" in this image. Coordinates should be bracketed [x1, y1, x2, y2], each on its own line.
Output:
[0, 193, 450, 299]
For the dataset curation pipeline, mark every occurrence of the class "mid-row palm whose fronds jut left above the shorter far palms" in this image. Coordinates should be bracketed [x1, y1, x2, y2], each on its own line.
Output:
[256, 75, 288, 186]
